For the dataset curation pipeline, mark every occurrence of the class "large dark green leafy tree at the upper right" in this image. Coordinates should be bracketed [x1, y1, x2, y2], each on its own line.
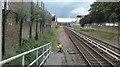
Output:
[89, 2, 120, 23]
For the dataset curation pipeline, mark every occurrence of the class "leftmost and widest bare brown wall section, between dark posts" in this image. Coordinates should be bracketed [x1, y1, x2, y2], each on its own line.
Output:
[5, 13, 20, 55]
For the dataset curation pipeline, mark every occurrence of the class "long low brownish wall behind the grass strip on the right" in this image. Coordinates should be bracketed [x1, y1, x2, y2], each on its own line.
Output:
[84, 26, 118, 33]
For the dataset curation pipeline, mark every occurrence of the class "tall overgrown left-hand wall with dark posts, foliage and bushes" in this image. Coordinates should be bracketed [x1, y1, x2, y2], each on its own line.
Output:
[2, 2, 52, 59]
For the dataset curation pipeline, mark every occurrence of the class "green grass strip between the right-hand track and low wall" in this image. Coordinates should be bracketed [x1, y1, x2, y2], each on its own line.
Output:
[74, 28, 118, 44]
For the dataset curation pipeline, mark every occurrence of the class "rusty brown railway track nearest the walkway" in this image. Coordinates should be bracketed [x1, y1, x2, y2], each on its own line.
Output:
[64, 28, 119, 67]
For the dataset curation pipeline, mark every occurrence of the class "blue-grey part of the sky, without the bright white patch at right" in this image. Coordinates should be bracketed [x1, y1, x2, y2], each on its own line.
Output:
[45, 2, 90, 18]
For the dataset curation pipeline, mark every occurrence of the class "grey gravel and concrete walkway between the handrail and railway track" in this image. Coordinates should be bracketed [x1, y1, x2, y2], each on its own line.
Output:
[44, 27, 86, 66]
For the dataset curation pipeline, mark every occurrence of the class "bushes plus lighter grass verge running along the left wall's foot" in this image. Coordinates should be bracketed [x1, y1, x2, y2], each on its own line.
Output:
[4, 27, 60, 65]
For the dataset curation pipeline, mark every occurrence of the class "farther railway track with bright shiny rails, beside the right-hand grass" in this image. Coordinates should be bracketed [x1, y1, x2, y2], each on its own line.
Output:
[73, 31, 120, 64]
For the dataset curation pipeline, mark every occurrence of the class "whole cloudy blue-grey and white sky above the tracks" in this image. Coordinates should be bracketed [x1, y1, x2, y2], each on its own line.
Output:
[45, 2, 94, 18]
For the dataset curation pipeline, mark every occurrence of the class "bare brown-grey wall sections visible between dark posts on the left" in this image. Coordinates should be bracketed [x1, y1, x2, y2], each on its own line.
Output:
[5, 13, 40, 55]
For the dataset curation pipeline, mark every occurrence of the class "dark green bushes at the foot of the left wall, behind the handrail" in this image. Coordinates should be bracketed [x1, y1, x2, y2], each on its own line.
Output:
[4, 34, 50, 65]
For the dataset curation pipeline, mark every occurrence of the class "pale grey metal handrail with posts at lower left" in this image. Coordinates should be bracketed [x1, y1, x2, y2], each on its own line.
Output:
[0, 42, 51, 67]
